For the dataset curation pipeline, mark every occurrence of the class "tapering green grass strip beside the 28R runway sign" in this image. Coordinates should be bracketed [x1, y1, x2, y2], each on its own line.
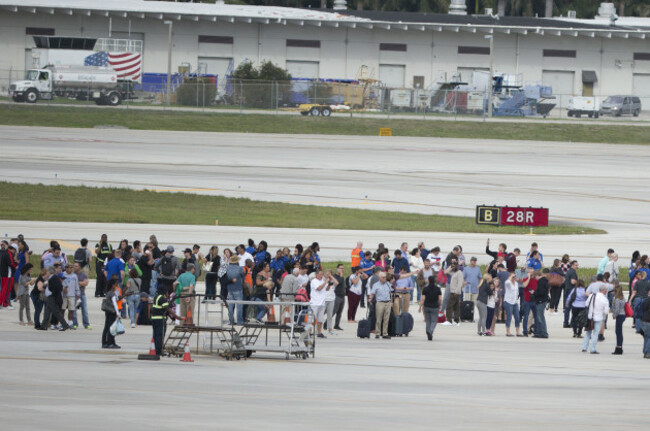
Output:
[0, 182, 604, 235]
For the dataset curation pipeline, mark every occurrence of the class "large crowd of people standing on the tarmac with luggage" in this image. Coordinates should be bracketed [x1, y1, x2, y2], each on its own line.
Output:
[0, 235, 650, 358]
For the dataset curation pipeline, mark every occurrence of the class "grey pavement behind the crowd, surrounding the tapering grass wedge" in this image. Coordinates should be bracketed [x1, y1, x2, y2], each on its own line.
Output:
[0, 126, 650, 266]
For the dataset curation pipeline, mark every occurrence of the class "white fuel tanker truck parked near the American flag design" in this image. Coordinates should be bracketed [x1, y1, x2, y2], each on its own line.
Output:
[9, 66, 133, 106]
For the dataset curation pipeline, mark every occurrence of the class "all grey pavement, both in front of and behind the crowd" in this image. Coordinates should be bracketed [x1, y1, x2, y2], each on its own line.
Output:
[0, 123, 650, 431]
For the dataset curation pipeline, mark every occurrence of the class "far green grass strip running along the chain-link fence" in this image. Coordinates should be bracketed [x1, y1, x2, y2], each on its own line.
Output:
[0, 104, 650, 145]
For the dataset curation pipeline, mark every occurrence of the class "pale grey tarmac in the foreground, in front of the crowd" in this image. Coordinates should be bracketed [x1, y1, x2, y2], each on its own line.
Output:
[0, 287, 650, 431]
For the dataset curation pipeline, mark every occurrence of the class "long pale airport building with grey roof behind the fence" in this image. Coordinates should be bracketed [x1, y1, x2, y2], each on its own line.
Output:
[0, 0, 650, 107]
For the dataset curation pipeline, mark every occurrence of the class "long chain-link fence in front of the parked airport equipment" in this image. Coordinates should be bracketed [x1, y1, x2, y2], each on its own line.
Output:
[0, 69, 650, 121]
